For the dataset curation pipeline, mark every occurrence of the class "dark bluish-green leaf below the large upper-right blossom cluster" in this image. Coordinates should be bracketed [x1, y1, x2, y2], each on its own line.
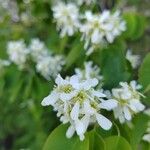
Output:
[100, 41, 130, 89]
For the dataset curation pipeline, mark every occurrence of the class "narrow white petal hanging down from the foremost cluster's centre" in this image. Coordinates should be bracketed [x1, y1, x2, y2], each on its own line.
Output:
[70, 102, 80, 120]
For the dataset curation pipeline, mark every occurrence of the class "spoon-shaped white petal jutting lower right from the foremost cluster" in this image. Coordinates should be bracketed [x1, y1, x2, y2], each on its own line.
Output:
[96, 114, 112, 130]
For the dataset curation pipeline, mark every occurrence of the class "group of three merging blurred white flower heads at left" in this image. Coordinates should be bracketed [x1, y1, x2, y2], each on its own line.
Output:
[7, 39, 65, 80]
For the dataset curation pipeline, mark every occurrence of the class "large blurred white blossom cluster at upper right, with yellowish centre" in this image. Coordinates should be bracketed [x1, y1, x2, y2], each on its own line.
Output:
[80, 10, 126, 55]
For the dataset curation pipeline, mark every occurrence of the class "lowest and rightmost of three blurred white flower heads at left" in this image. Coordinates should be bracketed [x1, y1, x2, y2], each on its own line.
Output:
[36, 55, 65, 80]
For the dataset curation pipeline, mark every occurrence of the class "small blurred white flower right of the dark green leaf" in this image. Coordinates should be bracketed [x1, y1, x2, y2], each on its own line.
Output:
[126, 50, 140, 69]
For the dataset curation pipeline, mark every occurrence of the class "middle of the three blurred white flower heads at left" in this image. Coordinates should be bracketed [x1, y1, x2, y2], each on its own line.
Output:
[29, 38, 48, 61]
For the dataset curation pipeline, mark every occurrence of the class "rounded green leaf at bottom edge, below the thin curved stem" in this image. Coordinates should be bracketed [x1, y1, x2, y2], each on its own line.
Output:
[105, 136, 131, 150]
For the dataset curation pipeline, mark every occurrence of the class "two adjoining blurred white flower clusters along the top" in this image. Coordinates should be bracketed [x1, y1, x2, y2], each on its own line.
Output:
[52, 0, 126, 55]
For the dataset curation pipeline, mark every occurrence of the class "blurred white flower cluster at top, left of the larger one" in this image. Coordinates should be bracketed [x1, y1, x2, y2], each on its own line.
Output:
[52, 2, 79, 37]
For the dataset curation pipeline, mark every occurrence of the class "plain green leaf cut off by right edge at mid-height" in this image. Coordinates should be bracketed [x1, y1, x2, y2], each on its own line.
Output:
[139, 53, 150, 90]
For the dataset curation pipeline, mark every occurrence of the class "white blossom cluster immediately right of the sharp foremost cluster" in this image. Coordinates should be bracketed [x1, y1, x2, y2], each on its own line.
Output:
[112, 81, 145, 123]
